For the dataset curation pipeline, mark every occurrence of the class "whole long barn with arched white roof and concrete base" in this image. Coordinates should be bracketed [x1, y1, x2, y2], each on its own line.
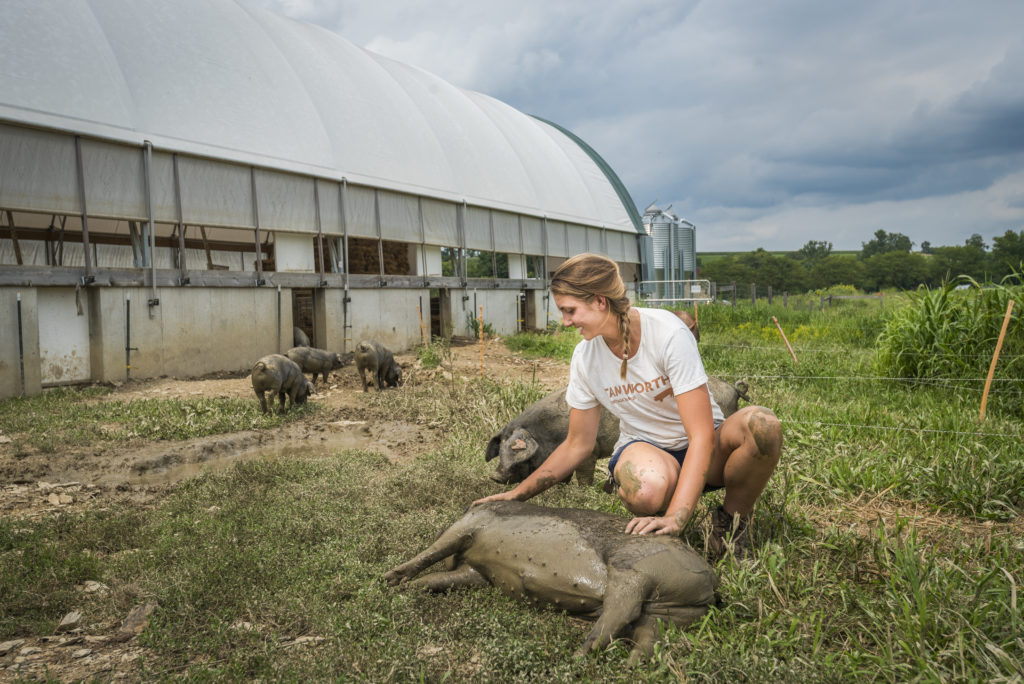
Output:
[0, 0, 643, 396]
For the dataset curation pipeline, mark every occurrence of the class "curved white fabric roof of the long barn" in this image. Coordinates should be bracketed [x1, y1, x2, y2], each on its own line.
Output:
[0, 0, 639, 232]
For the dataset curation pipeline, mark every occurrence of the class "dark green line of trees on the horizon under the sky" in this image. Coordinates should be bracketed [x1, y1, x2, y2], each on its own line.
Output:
[697, 230, 1024, 293]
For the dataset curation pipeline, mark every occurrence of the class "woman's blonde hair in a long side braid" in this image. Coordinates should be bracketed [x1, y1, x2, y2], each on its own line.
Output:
[551, 253, 630, 379]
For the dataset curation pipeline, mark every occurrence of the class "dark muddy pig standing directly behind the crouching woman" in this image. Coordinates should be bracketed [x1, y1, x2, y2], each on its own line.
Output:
[484, 377, 750, 484]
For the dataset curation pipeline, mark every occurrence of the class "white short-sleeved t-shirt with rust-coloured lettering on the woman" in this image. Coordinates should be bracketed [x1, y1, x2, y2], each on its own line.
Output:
[565, 307, 725, 451]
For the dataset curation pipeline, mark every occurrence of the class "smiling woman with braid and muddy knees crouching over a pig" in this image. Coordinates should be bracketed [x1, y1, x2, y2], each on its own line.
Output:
[473, 254, 782, 560]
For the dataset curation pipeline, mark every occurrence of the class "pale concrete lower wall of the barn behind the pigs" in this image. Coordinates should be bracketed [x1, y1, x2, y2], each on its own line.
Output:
[0, 274, 632, 397]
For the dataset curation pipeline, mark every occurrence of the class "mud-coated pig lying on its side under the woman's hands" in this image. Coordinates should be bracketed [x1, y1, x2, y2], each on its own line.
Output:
[384, 501, 717, 661]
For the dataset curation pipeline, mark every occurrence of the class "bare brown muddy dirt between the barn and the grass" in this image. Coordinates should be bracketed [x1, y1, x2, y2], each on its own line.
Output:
[0, 339, 568, 517]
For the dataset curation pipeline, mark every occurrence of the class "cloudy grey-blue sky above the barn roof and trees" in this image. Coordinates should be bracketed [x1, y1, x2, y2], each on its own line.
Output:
[254, 0, 1024, 251]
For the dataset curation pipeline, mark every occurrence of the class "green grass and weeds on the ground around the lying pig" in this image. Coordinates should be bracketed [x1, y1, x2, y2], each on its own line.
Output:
[0, 301, 1024, 682]
